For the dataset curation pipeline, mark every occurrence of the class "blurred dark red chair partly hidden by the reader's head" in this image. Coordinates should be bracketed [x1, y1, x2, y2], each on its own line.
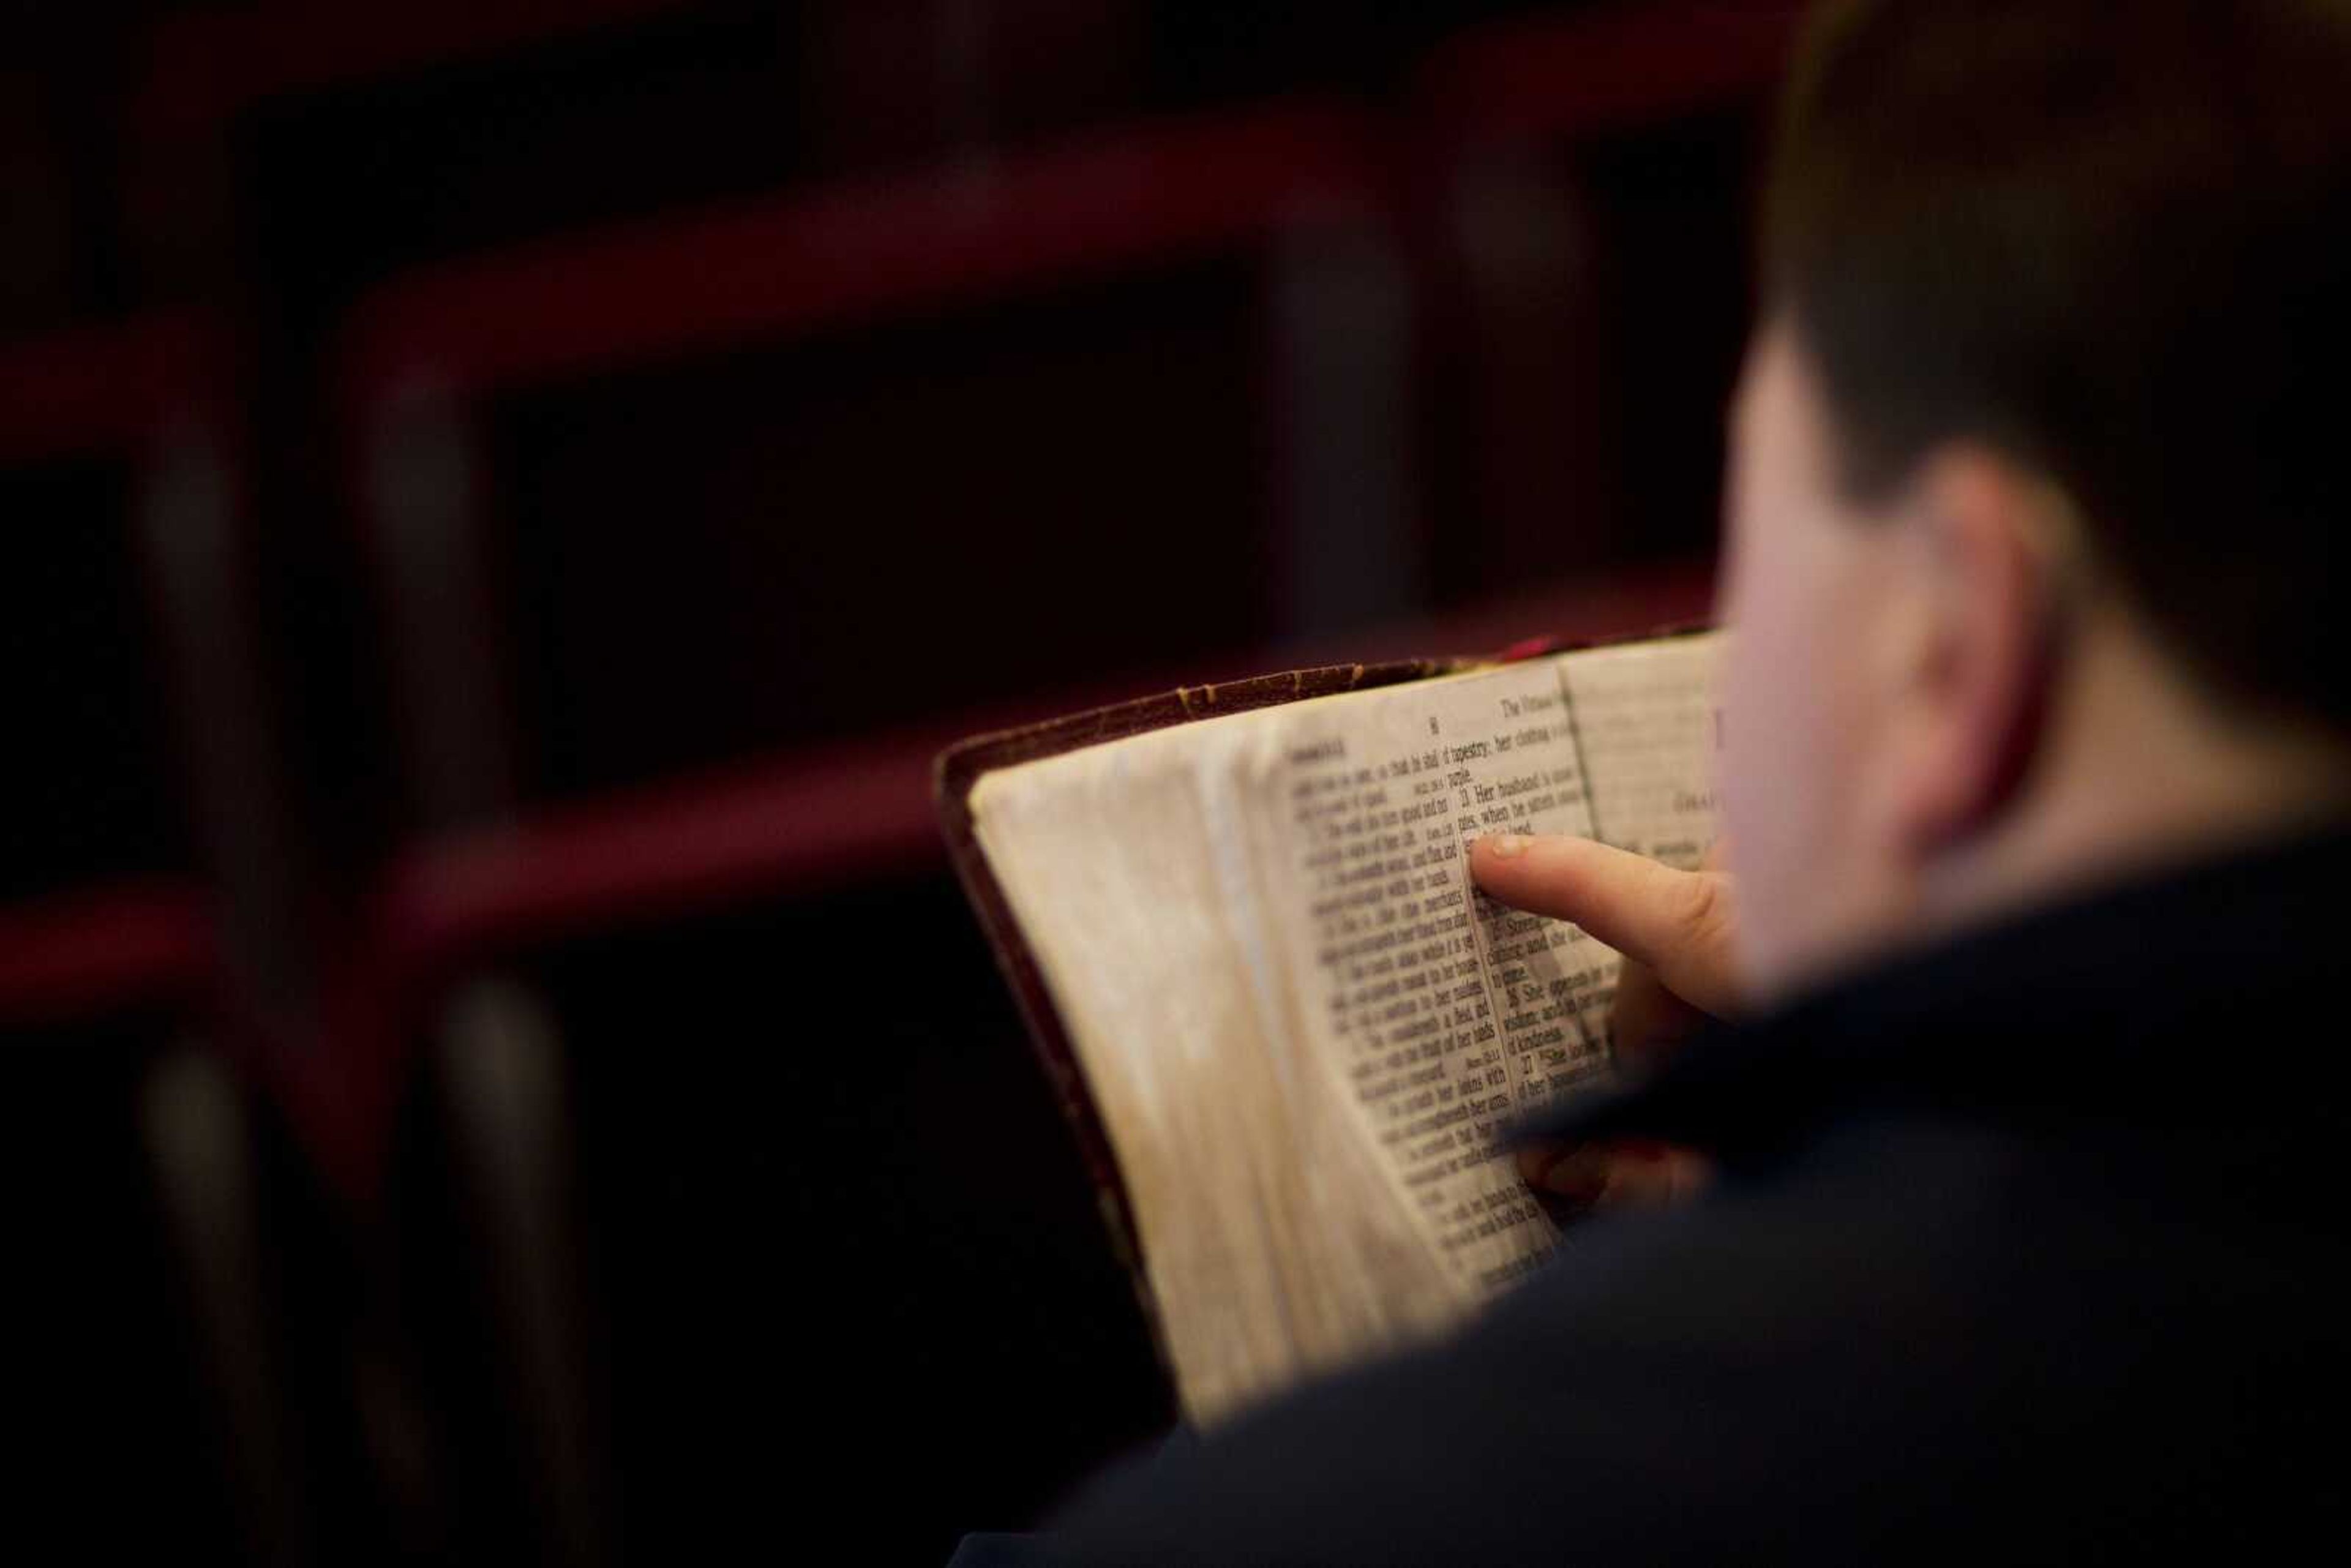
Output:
[1413, 0, 1803, 595]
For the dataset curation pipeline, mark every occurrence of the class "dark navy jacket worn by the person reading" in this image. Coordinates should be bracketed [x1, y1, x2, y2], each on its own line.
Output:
[973, 832, 2351, 1566]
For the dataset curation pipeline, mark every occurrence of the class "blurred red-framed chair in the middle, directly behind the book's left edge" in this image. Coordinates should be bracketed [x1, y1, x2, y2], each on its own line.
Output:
[343, 103, 1413, 1540]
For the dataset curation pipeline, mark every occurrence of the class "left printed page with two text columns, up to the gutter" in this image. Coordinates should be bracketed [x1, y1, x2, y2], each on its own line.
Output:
[1274, 661, 1613, 1293]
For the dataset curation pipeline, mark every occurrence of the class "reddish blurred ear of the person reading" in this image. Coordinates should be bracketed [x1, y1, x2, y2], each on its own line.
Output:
[1878, 447, 2057, 860]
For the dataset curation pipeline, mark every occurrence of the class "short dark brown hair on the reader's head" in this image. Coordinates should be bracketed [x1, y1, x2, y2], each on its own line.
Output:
[1763, 0, 2351, 729]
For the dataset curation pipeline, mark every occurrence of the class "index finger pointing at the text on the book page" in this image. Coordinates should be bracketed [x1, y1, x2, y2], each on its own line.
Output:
[1469, 832, 1740, 1016]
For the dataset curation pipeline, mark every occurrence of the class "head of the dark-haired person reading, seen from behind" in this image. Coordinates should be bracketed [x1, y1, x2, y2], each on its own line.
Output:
[1721, 0, 2351, 989]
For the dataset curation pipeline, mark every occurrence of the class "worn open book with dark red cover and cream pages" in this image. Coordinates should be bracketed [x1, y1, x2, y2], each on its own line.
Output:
[938, 632, 1721, 1422]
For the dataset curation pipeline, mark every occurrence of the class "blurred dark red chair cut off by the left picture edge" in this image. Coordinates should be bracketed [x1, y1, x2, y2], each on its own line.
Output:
[0, 317, 364, 1561]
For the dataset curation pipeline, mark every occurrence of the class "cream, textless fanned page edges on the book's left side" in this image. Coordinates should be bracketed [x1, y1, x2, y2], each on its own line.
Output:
[971, 698, 1464, 1422]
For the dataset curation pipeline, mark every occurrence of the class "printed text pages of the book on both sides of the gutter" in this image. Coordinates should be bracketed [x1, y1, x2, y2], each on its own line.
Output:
[1277, 635, 1721, 1293]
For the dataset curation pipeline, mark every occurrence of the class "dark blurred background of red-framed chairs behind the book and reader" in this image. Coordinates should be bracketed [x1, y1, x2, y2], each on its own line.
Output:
[0, 0, 1791, 1563]
